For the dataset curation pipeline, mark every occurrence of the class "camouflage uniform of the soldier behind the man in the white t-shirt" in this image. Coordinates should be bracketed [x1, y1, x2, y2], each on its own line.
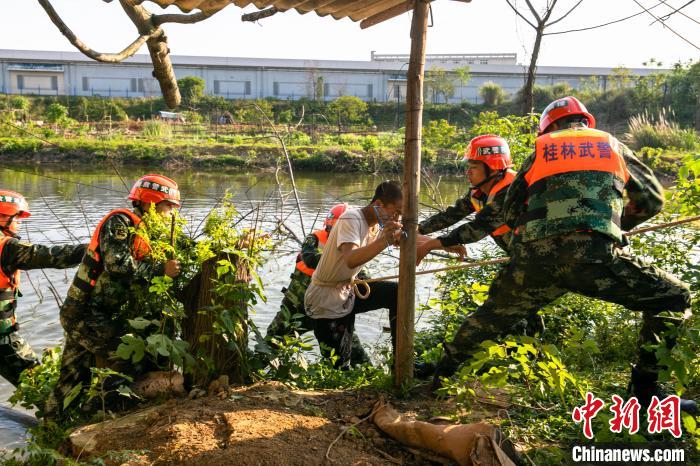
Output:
[265, 233, 370, 364]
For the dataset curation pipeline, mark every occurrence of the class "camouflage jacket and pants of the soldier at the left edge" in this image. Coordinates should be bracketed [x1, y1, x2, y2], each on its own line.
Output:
[0, 238, 86, 386]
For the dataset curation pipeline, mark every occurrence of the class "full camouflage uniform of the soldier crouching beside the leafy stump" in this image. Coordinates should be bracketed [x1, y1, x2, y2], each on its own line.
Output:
[46, 209, 164, 417]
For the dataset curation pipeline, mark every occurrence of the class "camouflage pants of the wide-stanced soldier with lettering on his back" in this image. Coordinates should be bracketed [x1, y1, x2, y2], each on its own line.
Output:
[441, 250, 690, 375]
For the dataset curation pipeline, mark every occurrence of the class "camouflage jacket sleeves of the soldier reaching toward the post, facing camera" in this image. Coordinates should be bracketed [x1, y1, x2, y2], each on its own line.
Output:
[418, 189, 511, 252]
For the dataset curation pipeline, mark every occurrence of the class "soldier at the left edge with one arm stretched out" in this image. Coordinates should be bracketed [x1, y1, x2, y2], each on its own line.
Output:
[0, 190, 86, 386]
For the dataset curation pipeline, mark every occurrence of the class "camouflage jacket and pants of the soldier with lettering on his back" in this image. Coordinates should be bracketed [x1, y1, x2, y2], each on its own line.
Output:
[438, 130, 690, 376]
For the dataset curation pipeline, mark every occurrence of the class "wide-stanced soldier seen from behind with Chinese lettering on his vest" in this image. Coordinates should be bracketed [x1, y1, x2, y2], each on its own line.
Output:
[433, 97, 697, 413]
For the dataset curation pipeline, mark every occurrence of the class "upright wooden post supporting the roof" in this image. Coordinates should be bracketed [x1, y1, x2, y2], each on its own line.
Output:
[394, 0, 429, 387]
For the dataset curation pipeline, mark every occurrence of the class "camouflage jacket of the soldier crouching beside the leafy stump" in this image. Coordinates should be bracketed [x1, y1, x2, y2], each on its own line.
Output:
[61, 214, 164, 352]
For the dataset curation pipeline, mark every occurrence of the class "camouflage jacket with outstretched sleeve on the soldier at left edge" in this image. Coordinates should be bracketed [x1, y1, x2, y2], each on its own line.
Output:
[0, 238, 87, 333]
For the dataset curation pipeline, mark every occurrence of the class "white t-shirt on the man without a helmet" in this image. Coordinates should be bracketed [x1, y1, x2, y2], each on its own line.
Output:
[304, 209, 377, 319]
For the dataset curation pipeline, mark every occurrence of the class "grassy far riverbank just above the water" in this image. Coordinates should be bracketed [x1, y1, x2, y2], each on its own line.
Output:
[0, 137, 459, 174]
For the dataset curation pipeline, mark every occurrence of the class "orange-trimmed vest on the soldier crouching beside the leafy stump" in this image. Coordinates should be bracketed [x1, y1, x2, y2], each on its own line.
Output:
[68, 209, 150, 302]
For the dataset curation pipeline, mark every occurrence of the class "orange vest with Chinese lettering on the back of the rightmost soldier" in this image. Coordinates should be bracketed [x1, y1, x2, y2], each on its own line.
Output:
[516, 128, 630, 242]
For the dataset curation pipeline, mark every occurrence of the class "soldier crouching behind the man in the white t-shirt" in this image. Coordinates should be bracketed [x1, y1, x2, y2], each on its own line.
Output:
[265, 204, 370, 364]
